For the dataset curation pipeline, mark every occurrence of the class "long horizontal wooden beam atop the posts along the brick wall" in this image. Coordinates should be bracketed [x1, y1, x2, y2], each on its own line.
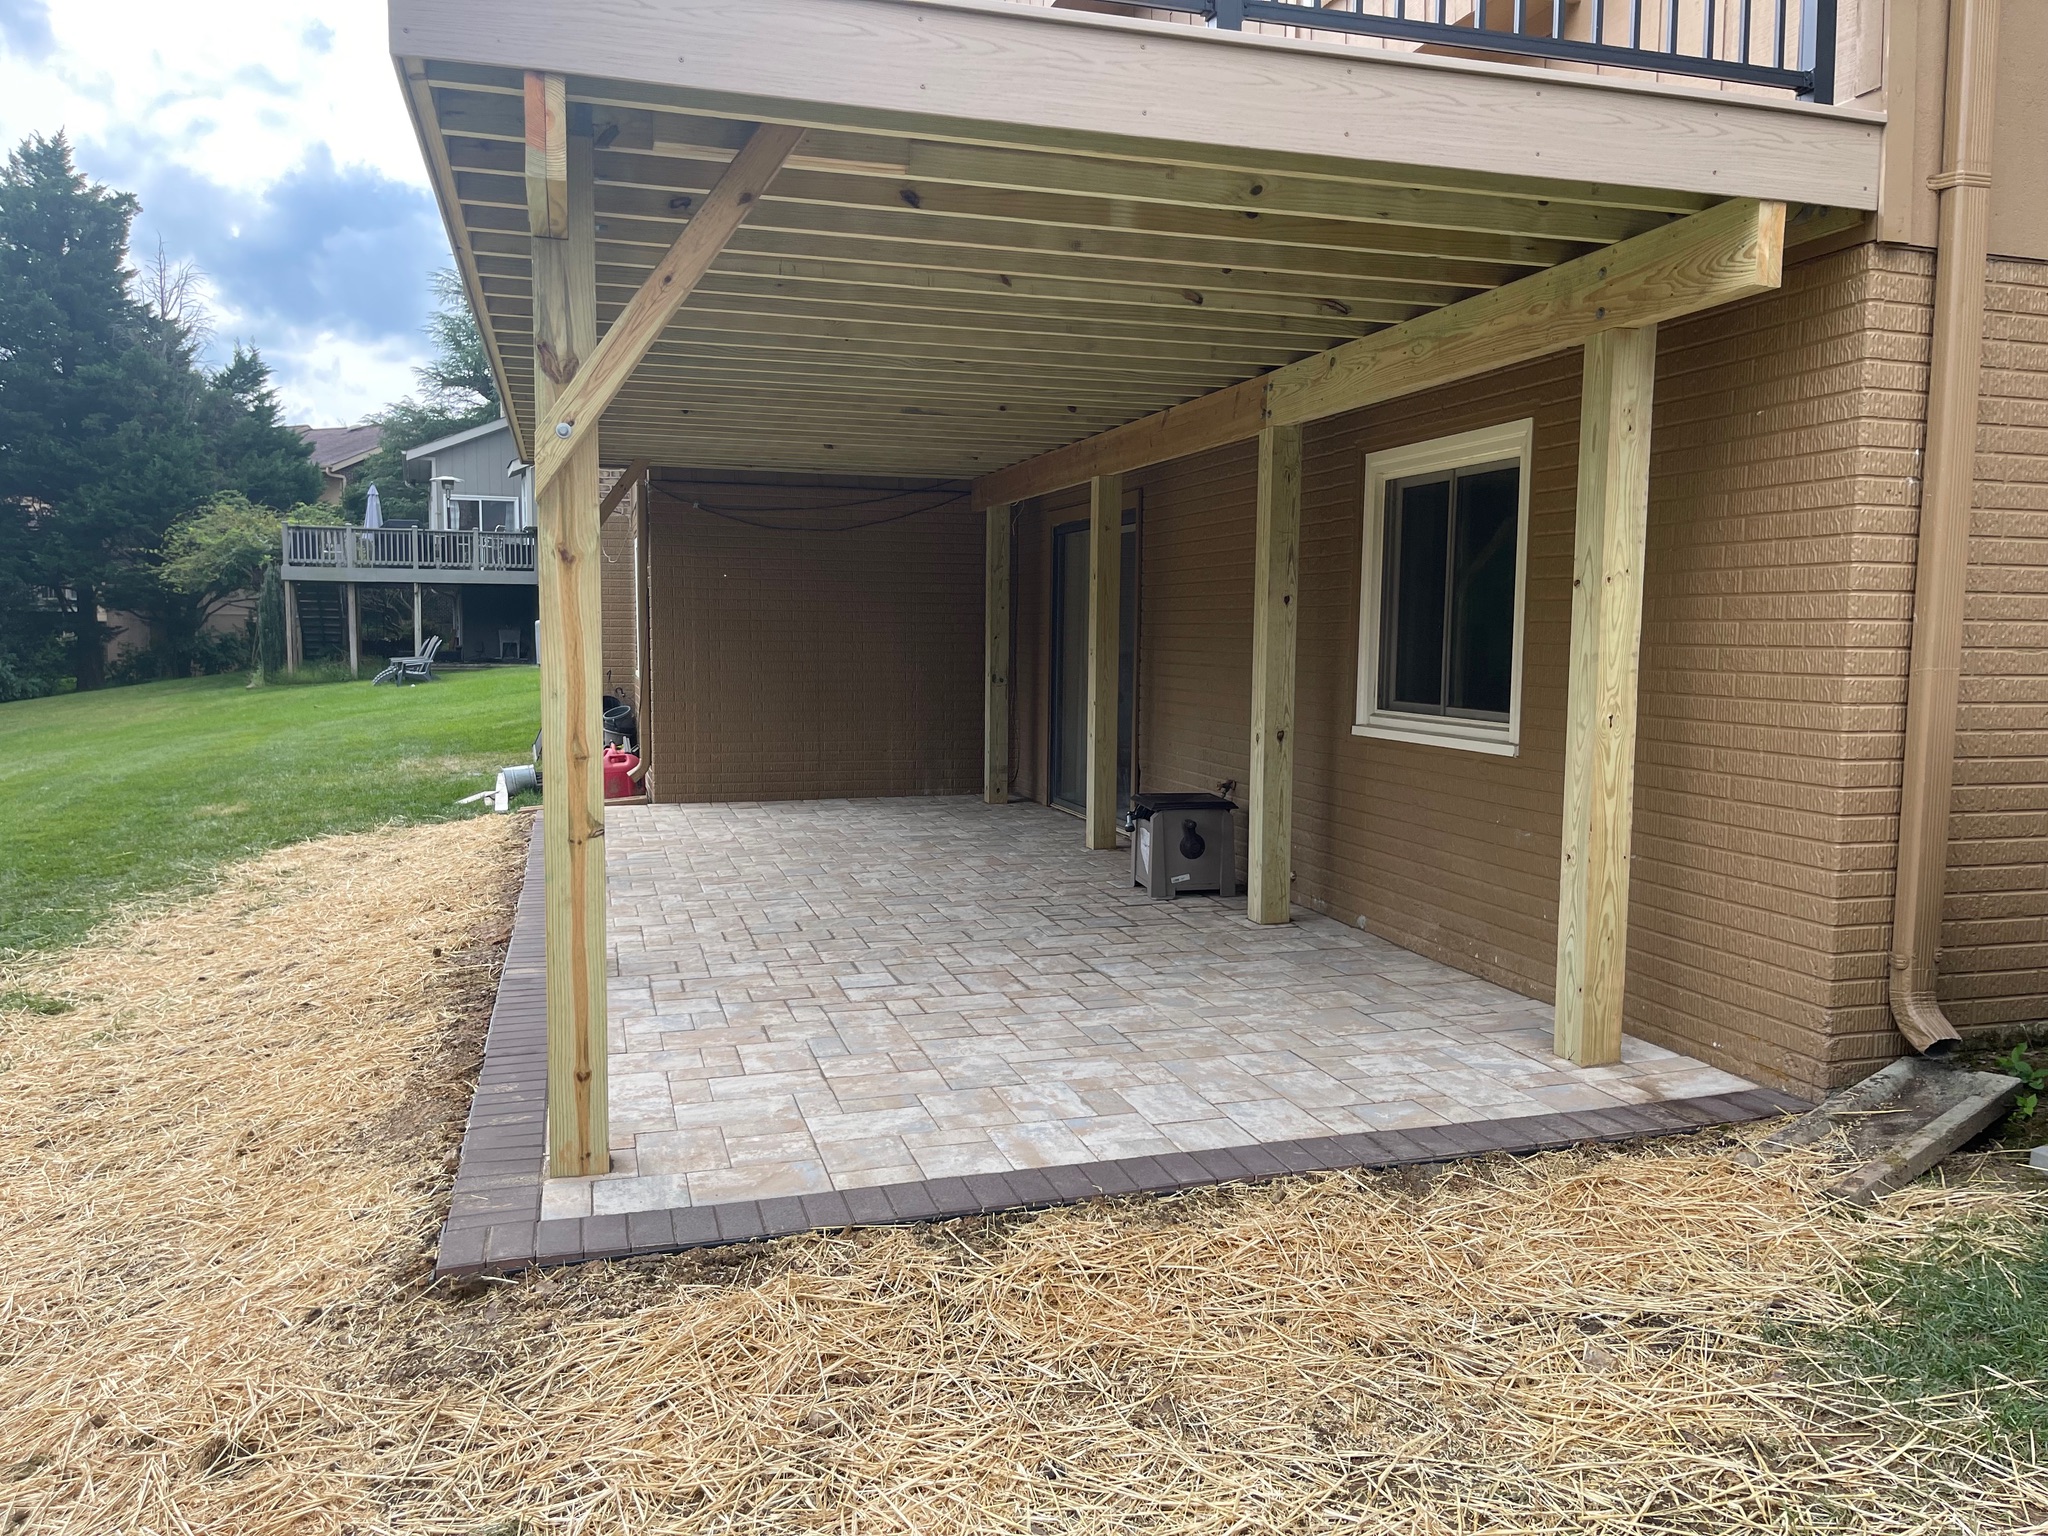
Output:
[973, 199, 1786, 506]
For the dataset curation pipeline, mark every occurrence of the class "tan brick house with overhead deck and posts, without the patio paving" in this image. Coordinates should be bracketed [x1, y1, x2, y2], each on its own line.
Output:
[391, 0, 2048, 1241]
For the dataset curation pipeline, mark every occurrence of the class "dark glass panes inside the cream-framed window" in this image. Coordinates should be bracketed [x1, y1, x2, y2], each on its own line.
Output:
[1380, 463, 1522, 721]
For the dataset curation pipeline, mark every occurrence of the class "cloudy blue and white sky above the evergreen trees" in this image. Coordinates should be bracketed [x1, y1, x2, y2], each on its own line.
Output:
[0, 0, 453, 426]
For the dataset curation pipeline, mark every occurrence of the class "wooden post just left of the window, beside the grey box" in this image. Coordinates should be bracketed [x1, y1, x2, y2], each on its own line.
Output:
[1245, 426, 1300, 924]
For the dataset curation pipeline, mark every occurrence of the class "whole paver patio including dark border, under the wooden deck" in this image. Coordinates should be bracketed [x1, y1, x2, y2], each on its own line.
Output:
[440, 799, 1794, 1272]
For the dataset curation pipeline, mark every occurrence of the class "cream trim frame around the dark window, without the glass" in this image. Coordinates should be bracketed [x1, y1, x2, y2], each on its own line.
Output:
[1352, 416, 1536, 758]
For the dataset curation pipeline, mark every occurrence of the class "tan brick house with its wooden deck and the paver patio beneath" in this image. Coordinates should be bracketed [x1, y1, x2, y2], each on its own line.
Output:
[391, 0, 2048, 1268]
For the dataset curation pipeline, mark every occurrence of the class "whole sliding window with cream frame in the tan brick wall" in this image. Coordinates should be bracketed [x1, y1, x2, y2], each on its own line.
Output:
[1352, 420, 1534, 756]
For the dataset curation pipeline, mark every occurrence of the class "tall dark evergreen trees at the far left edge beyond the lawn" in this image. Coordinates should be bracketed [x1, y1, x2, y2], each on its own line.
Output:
[0, 133, 319, 692]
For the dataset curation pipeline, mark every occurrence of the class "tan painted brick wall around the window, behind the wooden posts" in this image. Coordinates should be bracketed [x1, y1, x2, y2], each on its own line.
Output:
[1018, 246, 2048, 1092]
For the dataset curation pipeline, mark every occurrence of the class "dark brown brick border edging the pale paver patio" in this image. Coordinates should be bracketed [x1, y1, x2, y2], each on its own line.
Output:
[434, 821, 1810, 1276]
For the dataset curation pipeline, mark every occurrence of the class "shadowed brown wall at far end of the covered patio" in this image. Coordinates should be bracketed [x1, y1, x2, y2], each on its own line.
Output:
[645, 475, 983, 801]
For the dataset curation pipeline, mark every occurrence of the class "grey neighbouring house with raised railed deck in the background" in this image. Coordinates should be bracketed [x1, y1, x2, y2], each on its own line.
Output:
[281, 420, 537, 672]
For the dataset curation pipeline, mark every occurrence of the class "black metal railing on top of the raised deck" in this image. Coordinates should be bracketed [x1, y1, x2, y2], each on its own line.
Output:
[1139, 0, 1837, 102]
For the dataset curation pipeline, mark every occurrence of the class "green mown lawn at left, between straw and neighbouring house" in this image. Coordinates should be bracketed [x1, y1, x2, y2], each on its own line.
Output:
[0, 668, 541, 956]
